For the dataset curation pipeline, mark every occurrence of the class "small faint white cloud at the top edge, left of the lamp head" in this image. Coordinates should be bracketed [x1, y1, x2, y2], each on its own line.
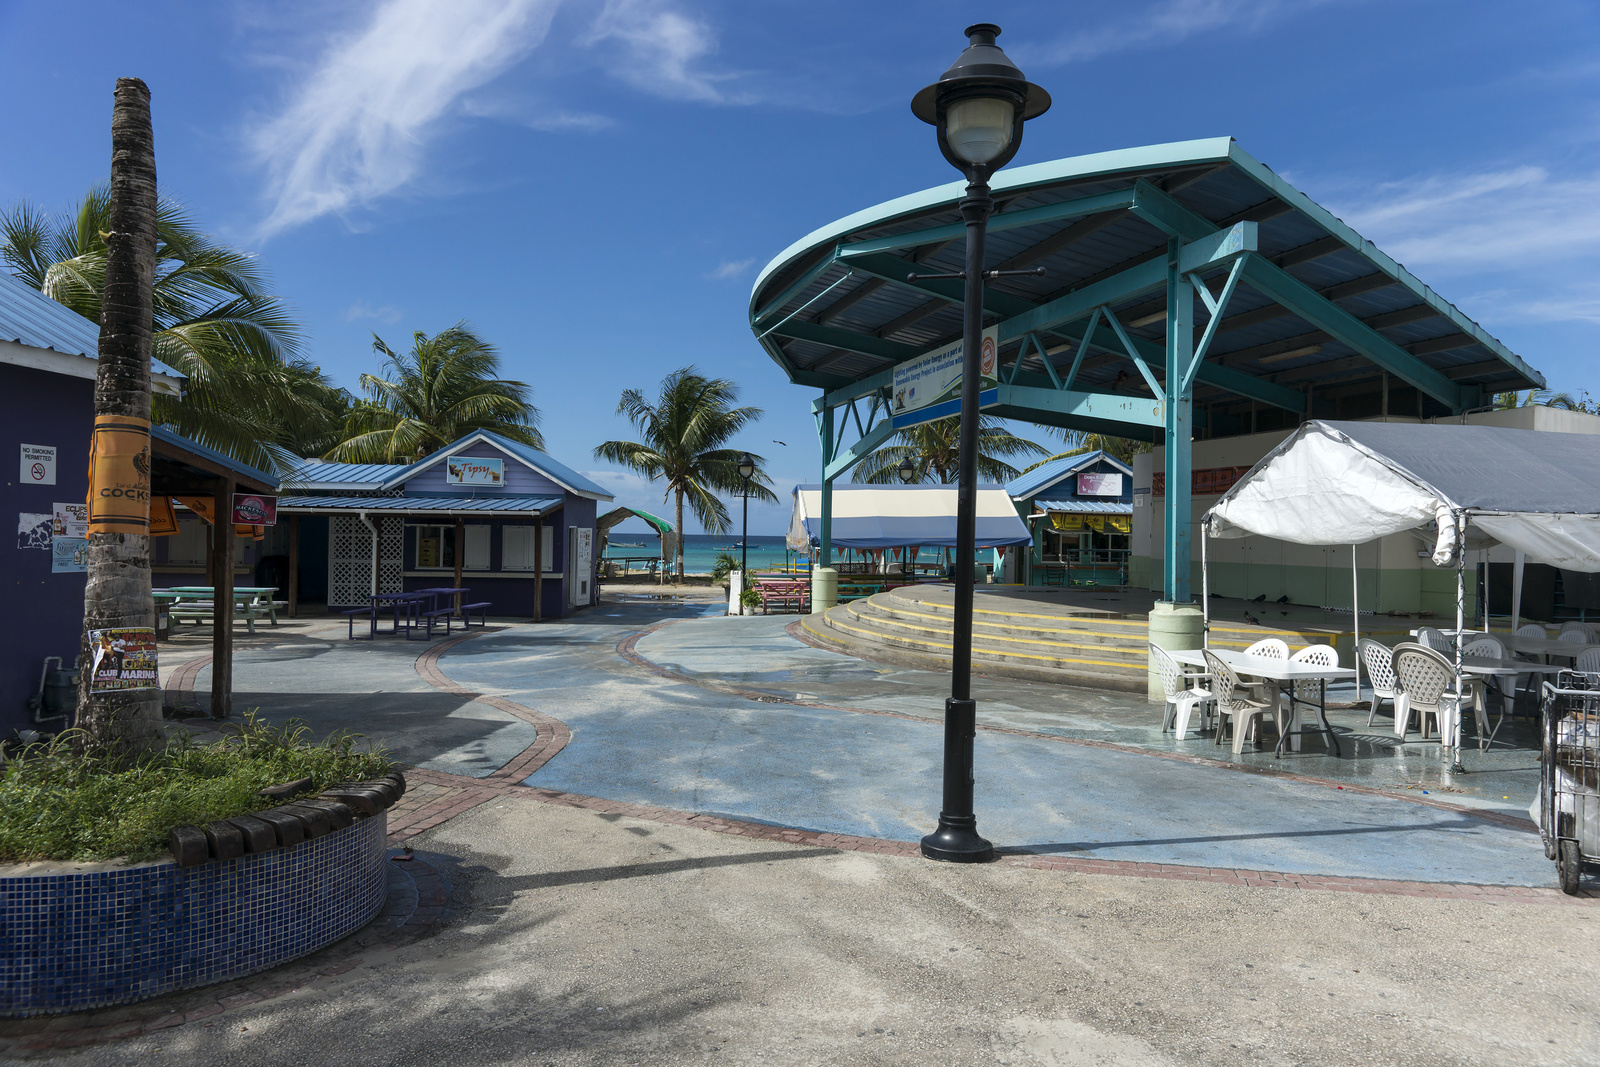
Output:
[582, 0, 749, 104]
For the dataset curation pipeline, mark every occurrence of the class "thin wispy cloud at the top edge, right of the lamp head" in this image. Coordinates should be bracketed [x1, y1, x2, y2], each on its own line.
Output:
[1014, 0, 1328, 64]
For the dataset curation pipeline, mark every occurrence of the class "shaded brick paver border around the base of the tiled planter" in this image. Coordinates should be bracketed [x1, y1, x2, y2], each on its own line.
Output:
[0, 851, 450, 1057]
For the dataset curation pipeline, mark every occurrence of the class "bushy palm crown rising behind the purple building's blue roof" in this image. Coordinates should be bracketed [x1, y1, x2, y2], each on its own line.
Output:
[328, 322, 544, 462]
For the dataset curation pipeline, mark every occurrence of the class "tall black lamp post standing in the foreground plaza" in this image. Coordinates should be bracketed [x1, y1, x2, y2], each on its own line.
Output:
[910, 22, 1050, 864]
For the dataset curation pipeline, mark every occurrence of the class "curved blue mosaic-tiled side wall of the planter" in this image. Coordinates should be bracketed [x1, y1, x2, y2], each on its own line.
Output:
[0, 813, 387, 1017]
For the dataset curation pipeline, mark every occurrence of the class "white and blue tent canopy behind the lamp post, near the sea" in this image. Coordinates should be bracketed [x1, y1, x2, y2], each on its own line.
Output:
[789, 485, 1034, 552]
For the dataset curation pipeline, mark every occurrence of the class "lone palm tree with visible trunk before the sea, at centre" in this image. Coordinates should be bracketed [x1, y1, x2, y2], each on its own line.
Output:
[595, 366, 778, 576]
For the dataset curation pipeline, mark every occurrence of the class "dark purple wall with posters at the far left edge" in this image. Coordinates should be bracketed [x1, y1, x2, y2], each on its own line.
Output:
[0, 363, 94, 736]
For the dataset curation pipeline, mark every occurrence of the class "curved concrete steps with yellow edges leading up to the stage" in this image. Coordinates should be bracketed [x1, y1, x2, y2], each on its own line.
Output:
[802, 590, 1149, 693]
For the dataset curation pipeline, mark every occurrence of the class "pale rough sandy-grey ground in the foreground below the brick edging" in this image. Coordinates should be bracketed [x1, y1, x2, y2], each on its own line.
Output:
[46, 798, 1600, 1067]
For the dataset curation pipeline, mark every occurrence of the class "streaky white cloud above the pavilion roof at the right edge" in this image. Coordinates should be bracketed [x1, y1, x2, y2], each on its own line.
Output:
[1330, 165, 1600, 322]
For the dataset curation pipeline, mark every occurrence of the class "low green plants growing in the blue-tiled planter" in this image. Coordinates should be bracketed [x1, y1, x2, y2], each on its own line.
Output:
[0, 713, 394, 862]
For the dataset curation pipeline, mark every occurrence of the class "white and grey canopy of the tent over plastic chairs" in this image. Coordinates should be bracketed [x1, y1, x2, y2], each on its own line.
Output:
[1205, 421, 1600, 571]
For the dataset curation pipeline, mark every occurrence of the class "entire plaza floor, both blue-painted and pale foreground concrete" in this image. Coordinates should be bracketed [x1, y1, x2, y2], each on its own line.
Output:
[37, 601, 1600, 1067]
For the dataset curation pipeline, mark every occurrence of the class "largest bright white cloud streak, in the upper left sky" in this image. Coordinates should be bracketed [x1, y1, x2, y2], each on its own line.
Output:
[251, 0, 558, 235]
